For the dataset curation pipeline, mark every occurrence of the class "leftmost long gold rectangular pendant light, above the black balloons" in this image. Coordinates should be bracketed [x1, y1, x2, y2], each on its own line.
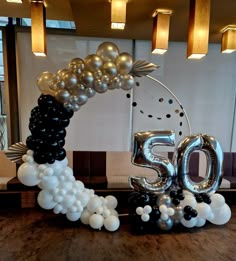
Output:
[31, 0, 47, 56]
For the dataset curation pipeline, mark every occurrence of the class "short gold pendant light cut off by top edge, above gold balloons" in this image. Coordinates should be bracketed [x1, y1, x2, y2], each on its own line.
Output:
[111, 0, 127, 30]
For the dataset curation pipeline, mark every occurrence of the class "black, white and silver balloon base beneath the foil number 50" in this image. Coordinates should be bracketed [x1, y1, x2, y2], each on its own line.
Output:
[128, 189, 231, 234]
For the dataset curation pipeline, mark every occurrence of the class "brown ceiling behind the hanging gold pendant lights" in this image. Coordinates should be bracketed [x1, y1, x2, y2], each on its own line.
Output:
[0, 0, 236, 42]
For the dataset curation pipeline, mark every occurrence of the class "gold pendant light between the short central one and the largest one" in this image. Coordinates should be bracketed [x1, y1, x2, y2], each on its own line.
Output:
[152, 9, 172, 54]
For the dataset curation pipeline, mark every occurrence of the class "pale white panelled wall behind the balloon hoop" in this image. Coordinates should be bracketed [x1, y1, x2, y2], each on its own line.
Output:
[17, 33, 236, 151]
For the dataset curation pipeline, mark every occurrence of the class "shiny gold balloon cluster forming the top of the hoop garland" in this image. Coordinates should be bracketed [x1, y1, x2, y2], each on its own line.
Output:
[37, 42, 135, 111]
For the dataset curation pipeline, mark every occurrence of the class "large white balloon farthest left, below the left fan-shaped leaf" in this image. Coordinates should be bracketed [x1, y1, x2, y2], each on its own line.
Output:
[17, 162, 40, 186]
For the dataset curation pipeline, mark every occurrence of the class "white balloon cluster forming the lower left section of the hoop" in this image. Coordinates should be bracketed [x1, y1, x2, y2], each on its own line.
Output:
[18, 150, 120, 231]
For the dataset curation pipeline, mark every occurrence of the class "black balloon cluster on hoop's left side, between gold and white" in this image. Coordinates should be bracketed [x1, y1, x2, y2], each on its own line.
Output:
[26, 95, 73, 164]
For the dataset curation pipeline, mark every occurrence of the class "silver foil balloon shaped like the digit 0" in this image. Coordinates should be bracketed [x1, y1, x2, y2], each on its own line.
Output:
[173, 134, 223, 193]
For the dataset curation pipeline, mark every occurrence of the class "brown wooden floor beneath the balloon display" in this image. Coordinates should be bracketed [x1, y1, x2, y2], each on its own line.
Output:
[0, 207, 236, 261]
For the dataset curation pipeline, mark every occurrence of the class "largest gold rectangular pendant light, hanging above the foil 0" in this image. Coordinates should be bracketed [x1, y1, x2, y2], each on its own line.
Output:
[187, 0, 211, 59]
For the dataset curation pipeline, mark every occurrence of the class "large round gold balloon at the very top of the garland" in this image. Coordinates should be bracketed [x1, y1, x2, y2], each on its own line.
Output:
[96, 42, 119, 62]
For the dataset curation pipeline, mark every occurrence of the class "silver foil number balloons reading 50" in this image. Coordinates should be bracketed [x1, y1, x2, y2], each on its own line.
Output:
[129, 131, 223, 193]
